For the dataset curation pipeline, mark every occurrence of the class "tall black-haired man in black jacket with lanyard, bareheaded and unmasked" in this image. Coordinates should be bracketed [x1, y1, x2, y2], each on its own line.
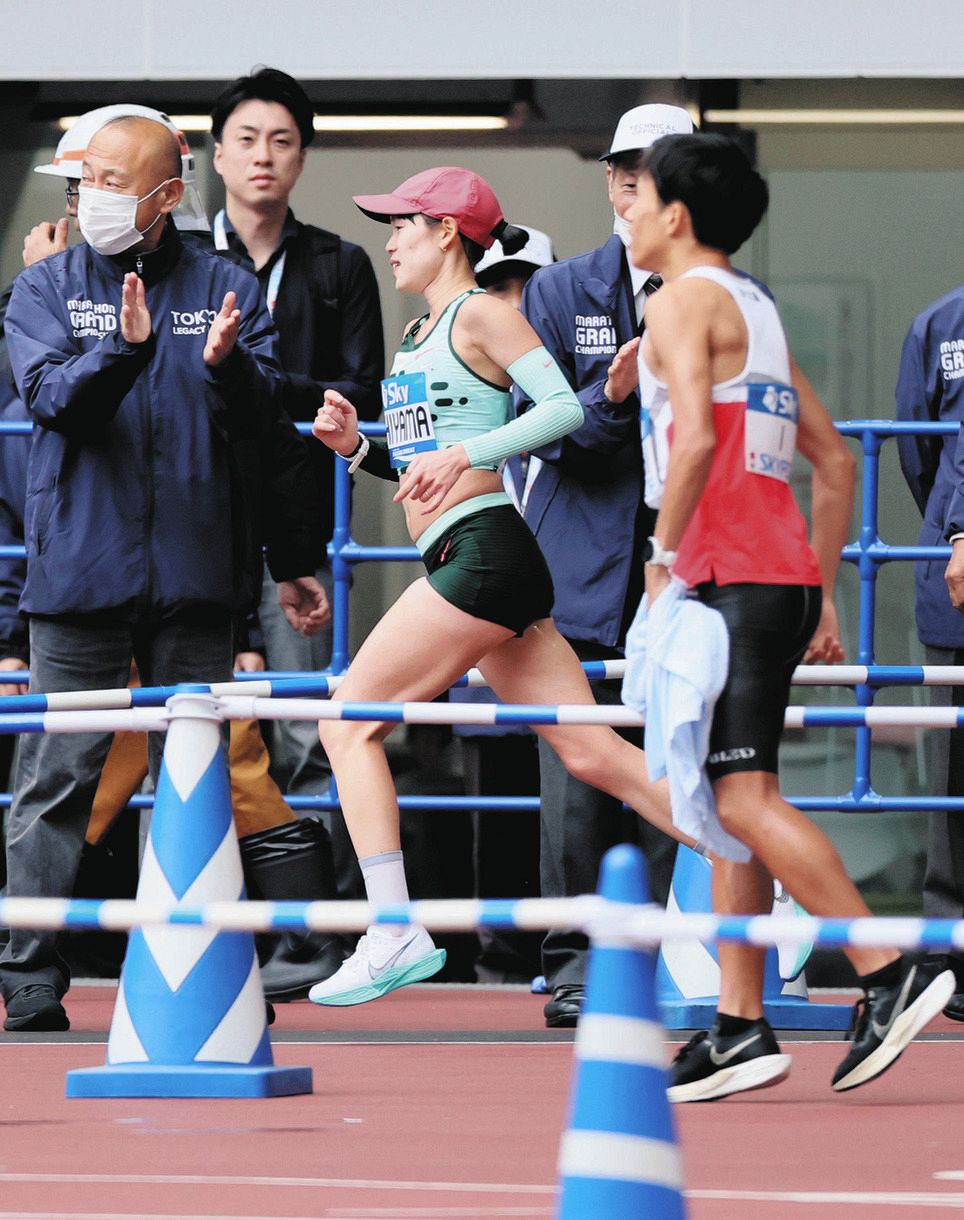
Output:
[211, 68, 384, 858]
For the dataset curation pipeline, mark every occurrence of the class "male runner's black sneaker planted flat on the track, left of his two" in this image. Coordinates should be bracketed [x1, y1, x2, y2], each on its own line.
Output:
[666, 1019, 792, 1102]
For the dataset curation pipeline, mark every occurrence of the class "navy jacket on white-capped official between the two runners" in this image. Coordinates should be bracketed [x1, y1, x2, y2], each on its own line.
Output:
[517, 235, 655, 647]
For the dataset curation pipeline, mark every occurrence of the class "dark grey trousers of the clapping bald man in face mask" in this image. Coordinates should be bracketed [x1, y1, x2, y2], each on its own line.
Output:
[0, 611, 234, 999]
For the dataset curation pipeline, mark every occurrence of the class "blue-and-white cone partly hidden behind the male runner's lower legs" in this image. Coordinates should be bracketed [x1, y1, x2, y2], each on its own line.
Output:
[656, 845, 853, 1030]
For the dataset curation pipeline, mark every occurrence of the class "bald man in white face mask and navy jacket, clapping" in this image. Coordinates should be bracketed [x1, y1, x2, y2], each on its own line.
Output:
[0, 118, 327, 1030]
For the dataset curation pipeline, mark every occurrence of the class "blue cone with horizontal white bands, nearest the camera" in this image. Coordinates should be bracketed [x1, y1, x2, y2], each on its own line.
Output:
[556, 844, 686, 1220]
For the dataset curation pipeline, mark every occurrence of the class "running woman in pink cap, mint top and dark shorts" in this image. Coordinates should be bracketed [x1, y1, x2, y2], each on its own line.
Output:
[310, 167, 692, 1005]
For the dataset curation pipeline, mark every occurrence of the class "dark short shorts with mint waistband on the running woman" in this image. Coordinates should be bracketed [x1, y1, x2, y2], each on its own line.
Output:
[422, 504, 553, 636]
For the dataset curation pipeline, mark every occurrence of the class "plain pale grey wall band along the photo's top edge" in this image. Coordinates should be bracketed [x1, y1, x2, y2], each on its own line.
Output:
[0, 0, 964, 81]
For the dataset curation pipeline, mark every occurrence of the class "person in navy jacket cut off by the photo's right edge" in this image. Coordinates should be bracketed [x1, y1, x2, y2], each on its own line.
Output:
[897, 280, 964, 1021]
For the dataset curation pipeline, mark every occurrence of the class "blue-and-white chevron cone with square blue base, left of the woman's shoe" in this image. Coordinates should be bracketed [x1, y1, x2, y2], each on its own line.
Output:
[67, 688, 311, 1097]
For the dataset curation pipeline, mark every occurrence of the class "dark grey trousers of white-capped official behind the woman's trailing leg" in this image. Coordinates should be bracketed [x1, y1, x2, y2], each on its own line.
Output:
[539, 641, 676, 988]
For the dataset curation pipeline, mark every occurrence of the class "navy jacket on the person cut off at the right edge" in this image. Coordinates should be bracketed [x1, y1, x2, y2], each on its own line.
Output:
[897, 288, 964, 648]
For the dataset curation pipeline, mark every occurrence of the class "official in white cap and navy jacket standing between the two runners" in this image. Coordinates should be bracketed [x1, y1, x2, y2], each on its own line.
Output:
[514, 105, 693, 1026]
